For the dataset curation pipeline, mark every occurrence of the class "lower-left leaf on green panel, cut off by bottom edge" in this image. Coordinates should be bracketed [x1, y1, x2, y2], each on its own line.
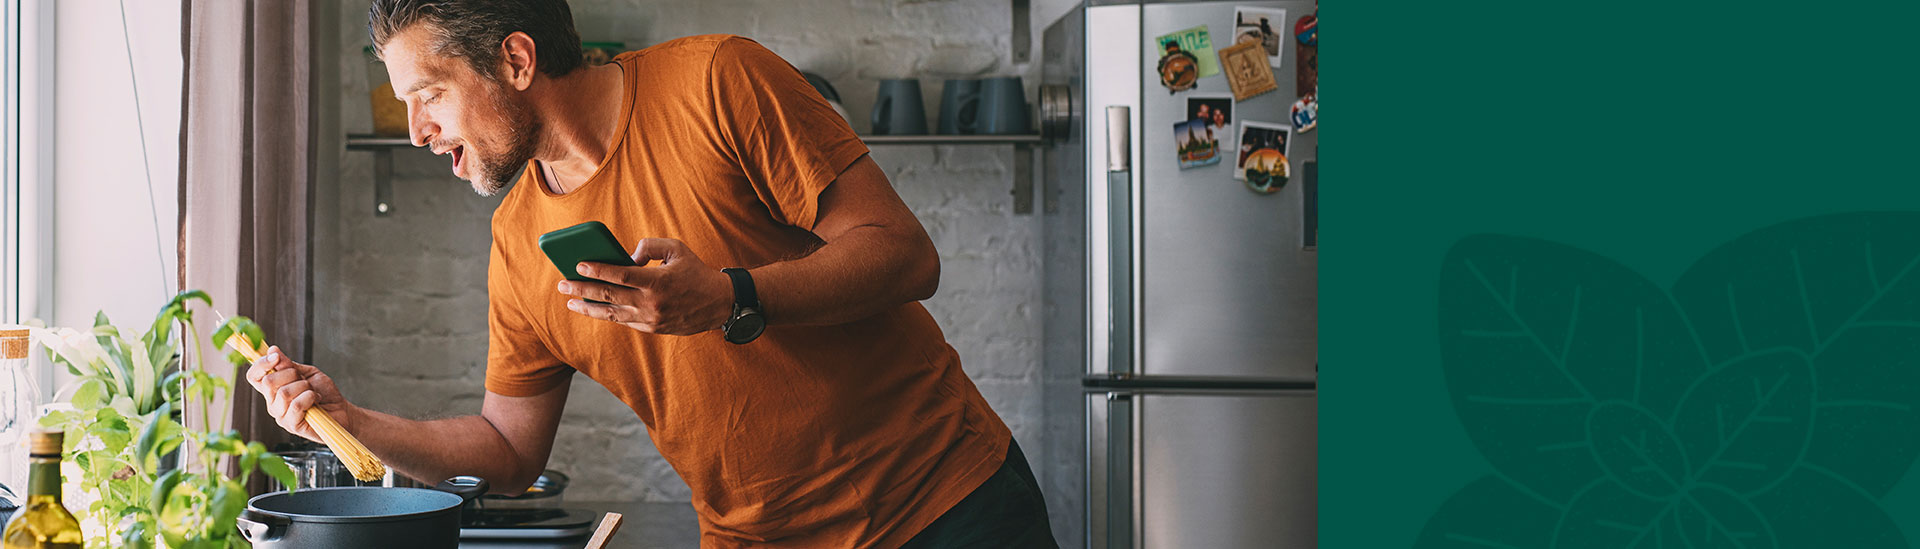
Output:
[1413, 476, 1559, 549]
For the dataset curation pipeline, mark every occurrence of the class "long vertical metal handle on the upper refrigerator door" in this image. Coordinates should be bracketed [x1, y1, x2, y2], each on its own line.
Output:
[1106, 106, 1135, 376]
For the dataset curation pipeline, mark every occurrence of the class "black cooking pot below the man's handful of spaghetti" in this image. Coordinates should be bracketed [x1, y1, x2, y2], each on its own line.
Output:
[238, 476, 488, 549]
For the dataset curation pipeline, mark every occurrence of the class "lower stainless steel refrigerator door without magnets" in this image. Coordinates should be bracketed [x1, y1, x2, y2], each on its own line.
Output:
[1133, 394, 1319, 549]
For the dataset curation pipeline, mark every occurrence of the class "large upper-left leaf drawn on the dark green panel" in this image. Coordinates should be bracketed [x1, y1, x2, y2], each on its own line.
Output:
[1438, 234, 1707, 503]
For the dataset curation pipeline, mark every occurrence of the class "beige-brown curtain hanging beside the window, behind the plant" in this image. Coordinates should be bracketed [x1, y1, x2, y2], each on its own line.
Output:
[179, 0, 313, 479]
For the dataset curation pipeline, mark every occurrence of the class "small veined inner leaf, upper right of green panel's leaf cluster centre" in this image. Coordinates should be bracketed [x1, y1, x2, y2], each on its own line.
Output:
[1672, 349, 1814, 495]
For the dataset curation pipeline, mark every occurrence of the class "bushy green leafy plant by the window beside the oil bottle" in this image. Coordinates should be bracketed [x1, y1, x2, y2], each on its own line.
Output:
[36, 290, 294, 549]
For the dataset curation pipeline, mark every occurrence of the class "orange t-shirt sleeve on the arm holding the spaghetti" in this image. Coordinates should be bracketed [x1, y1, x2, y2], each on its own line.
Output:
[486, 242, 572, 397]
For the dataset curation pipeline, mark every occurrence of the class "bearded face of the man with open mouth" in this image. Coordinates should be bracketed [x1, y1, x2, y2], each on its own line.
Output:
[382, 23, 540, 196]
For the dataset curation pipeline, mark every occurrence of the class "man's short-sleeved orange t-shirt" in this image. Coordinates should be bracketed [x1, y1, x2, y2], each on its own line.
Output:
[486, 35, 1010, 547]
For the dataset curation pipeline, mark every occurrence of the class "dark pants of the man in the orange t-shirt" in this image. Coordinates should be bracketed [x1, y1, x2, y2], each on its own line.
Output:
[900, 442, 1060, 549]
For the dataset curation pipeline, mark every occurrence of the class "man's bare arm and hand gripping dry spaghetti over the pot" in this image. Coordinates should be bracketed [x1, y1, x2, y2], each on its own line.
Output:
[246, 349, 570, 493]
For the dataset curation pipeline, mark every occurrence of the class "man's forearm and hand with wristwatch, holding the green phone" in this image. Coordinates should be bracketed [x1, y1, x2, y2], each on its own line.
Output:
[559, 157, 941, 334]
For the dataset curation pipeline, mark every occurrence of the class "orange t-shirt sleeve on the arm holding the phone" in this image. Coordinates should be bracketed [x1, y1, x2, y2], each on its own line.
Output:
[708, 36, 868, 230]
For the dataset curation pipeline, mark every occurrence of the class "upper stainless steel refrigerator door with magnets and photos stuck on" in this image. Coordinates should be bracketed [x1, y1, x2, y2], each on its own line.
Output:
[1136, 2, 1319, 380]
